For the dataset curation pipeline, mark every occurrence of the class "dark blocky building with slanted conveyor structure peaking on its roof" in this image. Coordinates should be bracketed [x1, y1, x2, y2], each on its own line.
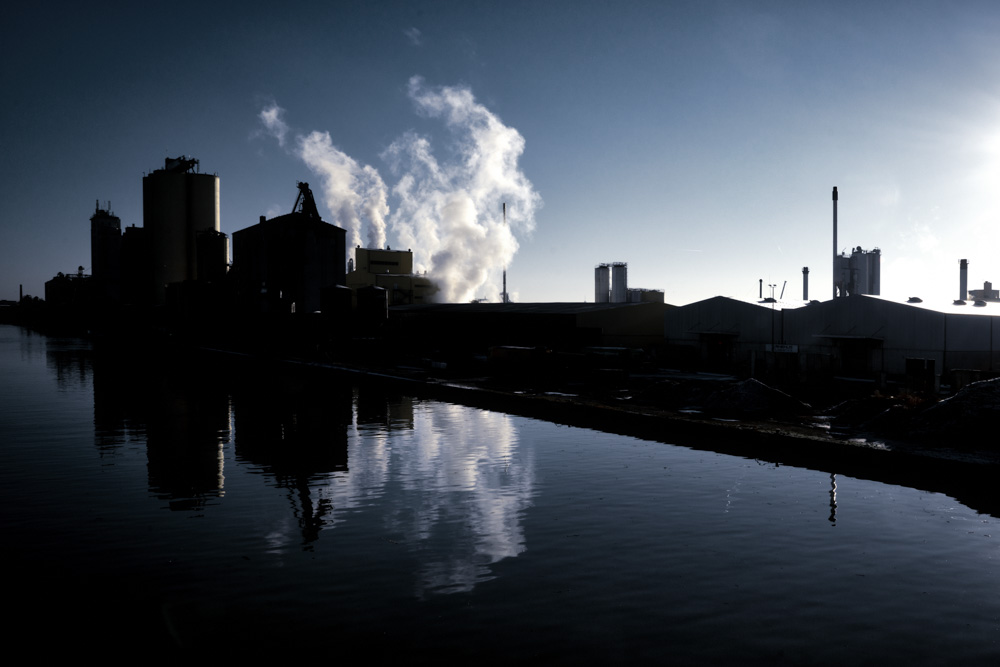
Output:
[233, 183, 347, 313]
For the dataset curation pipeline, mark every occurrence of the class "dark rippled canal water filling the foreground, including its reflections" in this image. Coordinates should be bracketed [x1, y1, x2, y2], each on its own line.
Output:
[0, 326, 1000, 665]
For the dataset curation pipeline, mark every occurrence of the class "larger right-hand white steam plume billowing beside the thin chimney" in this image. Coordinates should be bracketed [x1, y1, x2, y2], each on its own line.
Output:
[383, 77, 541, 301]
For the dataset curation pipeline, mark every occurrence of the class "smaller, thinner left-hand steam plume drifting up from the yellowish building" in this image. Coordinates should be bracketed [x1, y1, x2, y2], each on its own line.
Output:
[258, 105, 389, 253]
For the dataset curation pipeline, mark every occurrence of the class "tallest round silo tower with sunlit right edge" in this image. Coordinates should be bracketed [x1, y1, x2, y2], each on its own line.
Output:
[142, 157, 219, 303]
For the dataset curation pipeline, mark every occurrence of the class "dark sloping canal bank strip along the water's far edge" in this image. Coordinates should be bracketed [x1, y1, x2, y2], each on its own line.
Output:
[217, 350, 1000, 517]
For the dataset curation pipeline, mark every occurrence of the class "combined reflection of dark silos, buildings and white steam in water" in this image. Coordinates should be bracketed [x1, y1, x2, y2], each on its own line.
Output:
[90, 354, 535, 597]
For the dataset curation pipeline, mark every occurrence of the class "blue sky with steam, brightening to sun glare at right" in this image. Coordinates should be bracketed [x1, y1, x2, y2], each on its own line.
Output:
[0, 0, 1000, 305]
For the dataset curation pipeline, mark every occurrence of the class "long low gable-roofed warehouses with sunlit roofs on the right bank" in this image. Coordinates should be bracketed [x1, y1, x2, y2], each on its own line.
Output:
[664, 295, 1000, 381]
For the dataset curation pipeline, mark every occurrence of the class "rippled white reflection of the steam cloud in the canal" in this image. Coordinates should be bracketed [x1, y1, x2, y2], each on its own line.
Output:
[314, 398, 535, 596]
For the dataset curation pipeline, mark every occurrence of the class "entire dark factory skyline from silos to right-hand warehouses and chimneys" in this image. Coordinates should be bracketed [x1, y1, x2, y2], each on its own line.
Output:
[13, 156, 1000, 390]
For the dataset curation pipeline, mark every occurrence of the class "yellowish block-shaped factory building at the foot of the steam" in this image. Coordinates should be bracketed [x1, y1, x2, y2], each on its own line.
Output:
[347, 246, 438, 306]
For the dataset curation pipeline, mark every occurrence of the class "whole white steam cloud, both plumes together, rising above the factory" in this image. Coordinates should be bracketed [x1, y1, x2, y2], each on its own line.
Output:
[260, 77, 541, 302]
